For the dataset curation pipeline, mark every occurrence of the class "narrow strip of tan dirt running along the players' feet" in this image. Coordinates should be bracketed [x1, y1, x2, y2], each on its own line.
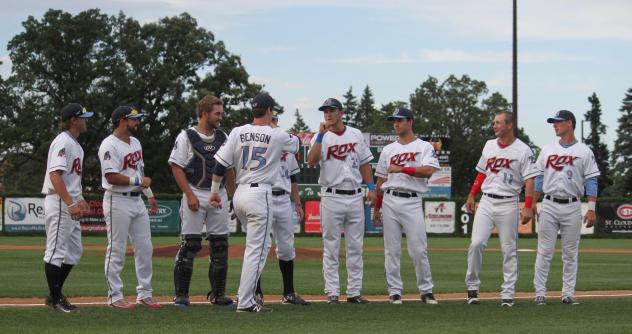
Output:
[0, 290, 632, 307]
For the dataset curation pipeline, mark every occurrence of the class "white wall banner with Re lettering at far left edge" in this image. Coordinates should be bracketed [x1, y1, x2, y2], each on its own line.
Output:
[4, 197, 46, 233]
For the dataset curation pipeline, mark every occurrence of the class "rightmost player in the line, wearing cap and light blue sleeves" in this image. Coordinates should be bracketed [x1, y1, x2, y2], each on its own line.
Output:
[533, 110, 600, 305]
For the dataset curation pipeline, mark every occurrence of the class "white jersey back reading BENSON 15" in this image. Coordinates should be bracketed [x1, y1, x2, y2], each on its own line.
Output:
[215, 124, 299, 185]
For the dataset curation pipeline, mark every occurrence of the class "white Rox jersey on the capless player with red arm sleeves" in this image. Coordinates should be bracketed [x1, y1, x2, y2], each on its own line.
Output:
[476, 139, 539, 196]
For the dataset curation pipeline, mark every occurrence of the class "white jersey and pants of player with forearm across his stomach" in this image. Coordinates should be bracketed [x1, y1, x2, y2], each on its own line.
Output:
[375, 139, 439, 296]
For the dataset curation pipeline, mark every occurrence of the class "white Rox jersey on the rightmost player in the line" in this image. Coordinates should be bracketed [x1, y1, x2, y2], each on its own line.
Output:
[536, 142, 601, 198]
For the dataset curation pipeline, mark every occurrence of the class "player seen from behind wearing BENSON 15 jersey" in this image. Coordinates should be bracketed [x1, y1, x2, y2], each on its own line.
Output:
[209, 93, 299, 312]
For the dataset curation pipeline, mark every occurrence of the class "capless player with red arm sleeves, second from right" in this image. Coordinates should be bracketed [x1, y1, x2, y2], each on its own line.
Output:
[465, 111, 538, 307]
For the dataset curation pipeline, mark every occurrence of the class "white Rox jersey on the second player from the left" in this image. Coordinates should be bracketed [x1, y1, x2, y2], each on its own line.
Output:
[99, 135, 145, 193]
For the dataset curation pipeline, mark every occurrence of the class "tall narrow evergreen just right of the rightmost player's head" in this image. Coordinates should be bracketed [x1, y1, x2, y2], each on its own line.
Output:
[584, 93, 612, 193]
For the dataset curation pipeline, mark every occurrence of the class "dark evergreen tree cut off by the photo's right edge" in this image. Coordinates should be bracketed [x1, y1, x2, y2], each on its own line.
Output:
[612, 88, 632, 196]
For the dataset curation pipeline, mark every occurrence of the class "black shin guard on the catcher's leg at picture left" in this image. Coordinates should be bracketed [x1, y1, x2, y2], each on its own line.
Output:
[173, 234, 202, 297]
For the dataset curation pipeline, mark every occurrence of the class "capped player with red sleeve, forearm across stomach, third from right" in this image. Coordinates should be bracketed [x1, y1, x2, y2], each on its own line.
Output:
[373, 108, 439, 304]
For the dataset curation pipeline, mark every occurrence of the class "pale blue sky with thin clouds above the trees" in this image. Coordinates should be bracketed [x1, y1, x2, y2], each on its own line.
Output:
[0, 0, 632, 148]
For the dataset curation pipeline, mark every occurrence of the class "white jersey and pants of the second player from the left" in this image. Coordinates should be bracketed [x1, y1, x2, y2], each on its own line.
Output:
[99, 135, 153, 304]
